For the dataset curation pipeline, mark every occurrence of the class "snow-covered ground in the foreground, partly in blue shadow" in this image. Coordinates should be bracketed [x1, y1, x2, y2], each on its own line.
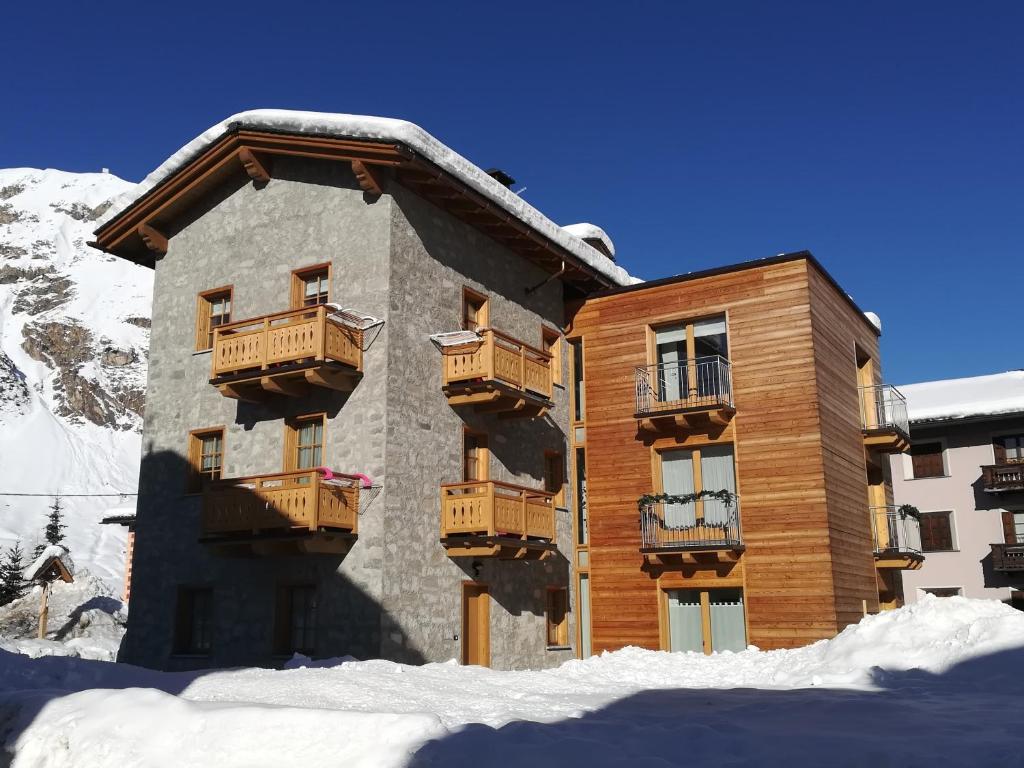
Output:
[0, 597, 1024, 768]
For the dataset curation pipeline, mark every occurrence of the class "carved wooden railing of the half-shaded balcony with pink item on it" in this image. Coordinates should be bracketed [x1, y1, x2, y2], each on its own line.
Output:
[202, 470, 360, 537]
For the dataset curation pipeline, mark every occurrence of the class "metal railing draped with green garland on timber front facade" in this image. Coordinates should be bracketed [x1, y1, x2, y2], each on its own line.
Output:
[640, 499, 742, 550]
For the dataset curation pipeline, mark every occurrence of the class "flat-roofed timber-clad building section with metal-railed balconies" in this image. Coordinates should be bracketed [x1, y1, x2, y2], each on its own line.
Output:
[567, 253, 921, 651]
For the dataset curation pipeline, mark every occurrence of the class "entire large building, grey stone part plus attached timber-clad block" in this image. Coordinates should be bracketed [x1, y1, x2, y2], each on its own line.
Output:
[96, 111, 916, 669]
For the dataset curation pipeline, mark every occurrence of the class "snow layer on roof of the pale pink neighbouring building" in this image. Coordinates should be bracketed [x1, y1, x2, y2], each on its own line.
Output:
[899, 371, 1024, 423]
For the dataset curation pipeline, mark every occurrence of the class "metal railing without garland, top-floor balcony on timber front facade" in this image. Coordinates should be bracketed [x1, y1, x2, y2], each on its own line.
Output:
[636, 355, 732, 415]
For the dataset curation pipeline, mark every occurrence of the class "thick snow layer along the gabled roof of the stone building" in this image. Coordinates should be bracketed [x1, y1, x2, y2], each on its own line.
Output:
[100, 110, 642, 286]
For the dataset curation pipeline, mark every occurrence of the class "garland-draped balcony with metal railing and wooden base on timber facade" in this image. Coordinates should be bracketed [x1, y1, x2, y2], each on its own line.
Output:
[640, 499, 744, 562]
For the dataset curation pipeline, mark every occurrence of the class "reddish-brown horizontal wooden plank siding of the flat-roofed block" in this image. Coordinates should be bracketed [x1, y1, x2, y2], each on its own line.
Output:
[568, 258, 878, 652]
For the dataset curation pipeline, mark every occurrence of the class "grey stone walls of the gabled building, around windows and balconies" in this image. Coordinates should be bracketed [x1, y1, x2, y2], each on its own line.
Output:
[122, 158, 574, 669]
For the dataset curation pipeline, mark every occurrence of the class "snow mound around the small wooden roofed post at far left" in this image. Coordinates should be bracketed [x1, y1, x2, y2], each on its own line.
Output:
[0, 573, 127, 663]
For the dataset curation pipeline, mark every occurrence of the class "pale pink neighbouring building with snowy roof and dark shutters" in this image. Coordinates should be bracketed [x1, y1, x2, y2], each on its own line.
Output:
[892, 371, 1024, 605]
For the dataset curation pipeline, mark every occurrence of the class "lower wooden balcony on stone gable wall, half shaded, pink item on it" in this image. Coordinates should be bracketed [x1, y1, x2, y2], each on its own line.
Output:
[201, 470, 360, 554]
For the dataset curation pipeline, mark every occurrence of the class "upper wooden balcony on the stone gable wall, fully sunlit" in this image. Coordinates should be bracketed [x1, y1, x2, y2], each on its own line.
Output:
[210, 306, 362, 402]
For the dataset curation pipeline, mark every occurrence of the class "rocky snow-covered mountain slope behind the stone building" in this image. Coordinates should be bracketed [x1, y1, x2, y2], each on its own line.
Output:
[0, 168, 153, 589]
